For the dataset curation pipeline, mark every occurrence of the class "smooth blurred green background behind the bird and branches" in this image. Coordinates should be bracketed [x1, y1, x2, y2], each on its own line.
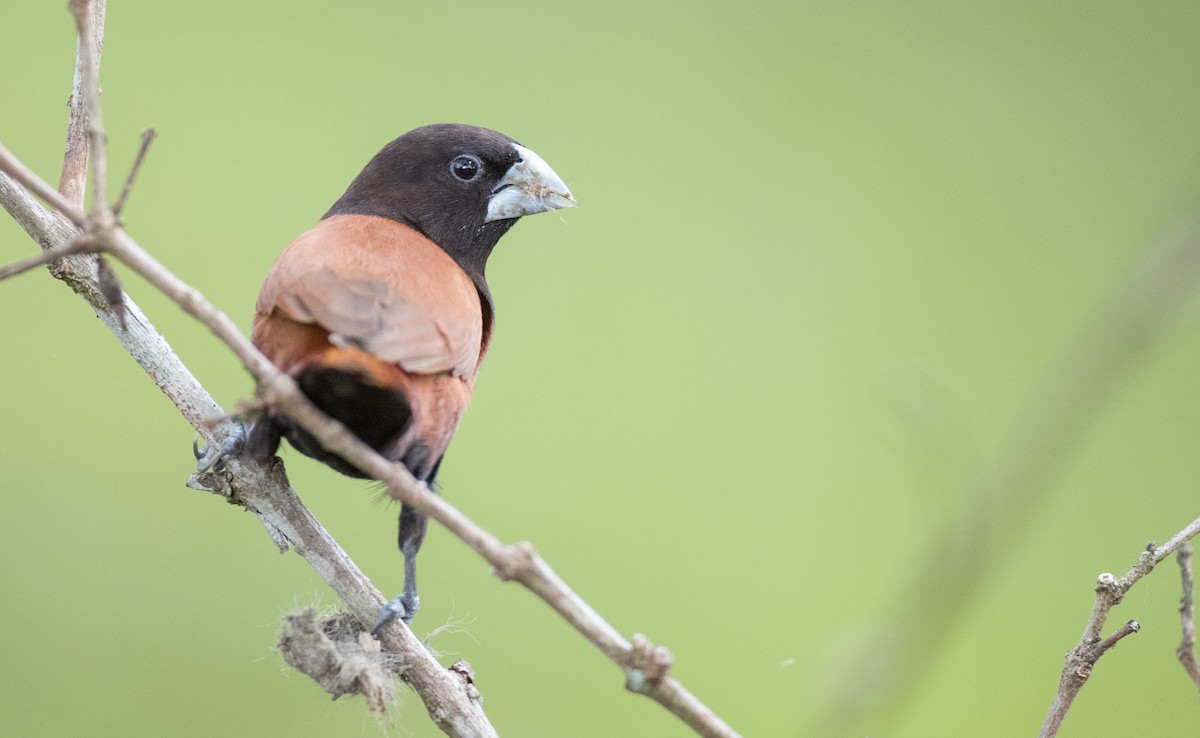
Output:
[0, 0, 1200, 737]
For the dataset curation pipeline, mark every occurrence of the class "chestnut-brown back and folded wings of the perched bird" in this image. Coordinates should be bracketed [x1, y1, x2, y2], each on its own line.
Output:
[257, 215, 484, 379]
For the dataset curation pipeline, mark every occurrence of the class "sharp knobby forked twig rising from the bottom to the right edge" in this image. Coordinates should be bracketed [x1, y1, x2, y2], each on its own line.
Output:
[1038, 518, 1200, 738]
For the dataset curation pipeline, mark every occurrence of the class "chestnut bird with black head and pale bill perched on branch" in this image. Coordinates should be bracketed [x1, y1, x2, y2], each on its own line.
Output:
[202, 124, 575, 634]
